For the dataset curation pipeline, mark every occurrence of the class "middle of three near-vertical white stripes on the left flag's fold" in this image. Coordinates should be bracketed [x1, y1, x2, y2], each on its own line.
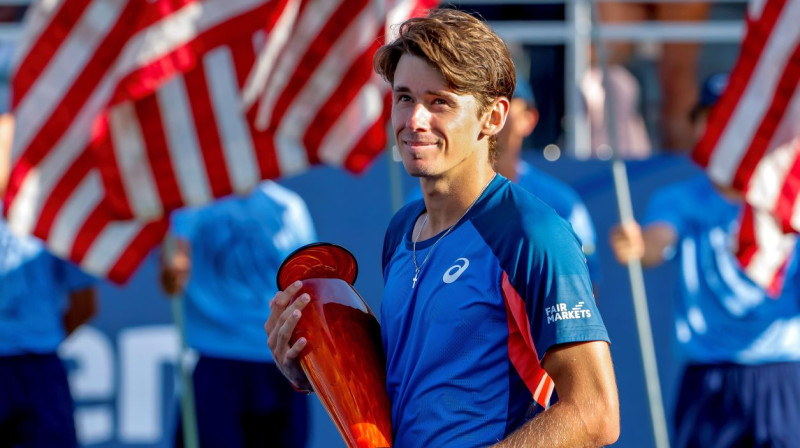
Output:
[155, 76, 213, 205]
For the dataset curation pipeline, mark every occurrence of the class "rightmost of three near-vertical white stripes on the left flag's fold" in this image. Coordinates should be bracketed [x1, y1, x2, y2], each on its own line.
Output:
[203, 47, 261, 193]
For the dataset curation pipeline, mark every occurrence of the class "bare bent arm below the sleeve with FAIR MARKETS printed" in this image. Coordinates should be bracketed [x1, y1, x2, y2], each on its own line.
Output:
[495, 341, 619, 448]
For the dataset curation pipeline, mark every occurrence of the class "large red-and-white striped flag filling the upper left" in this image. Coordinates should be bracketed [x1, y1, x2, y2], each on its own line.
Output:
[4, 0, 434, 282]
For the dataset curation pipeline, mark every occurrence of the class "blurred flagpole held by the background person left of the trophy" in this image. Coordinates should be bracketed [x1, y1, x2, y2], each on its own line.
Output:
[163, 233, 200, 448]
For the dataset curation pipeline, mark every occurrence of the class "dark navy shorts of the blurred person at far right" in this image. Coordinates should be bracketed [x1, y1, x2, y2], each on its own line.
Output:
[673, 363, 800, 448]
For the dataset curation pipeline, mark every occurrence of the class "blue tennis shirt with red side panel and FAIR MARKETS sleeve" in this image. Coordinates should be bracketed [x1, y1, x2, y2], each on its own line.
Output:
[381, 175, 608, 448]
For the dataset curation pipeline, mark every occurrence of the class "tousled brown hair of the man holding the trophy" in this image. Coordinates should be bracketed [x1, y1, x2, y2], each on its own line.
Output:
[373, 8, 517, 161]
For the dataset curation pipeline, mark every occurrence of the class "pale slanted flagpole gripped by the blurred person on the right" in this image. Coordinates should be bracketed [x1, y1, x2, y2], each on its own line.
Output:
[576, 0, 669, 448]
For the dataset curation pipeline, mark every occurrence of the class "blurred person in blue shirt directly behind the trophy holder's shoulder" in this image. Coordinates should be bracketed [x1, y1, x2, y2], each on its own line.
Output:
[494, 73, 600, 283]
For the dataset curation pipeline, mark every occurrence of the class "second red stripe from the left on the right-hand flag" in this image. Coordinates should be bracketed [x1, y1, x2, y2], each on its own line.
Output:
[732, 43, 800, 190]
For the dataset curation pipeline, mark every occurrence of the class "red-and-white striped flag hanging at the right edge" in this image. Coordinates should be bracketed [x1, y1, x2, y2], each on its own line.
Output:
[693, 0, 800, 295]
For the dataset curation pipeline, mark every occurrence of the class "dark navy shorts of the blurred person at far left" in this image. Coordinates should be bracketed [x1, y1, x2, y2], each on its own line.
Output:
[0, 353, 78, 448]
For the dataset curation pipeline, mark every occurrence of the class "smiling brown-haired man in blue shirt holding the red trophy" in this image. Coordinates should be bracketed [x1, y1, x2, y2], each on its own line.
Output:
[265, 9, 619, 448]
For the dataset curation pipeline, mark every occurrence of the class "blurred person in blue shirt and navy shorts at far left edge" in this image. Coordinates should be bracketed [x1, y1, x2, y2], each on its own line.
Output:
[0, 114, 97, 448]
